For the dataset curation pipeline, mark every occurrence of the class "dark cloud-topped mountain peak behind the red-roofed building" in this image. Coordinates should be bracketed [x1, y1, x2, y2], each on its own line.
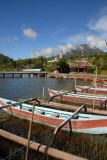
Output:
[63, 44, 104, 58]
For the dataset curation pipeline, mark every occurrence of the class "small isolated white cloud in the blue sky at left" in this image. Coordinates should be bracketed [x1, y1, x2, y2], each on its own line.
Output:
[23, 28, 37, 39]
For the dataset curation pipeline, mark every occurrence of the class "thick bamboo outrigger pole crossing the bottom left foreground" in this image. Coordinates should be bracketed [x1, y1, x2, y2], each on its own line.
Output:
[0, 129, 84, 160]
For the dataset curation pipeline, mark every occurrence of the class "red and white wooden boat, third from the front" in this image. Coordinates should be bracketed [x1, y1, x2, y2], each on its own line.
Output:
[76, 85, 107, 94]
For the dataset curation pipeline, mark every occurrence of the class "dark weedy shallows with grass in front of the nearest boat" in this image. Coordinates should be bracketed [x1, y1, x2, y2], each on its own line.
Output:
[0, 116, 107, 160]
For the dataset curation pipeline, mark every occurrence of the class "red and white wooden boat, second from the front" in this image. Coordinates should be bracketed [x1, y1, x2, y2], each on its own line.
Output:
[48, 89, 107, 105]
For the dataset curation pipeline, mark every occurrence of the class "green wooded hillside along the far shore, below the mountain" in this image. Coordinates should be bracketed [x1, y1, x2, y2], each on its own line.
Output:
[0, 52, 107, 74]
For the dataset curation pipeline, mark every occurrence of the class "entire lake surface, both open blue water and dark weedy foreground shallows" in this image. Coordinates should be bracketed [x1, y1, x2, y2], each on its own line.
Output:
[0, 77, 107, 160]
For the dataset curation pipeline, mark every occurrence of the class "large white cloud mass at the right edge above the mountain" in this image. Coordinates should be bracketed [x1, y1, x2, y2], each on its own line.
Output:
[86, 6, 107, 49]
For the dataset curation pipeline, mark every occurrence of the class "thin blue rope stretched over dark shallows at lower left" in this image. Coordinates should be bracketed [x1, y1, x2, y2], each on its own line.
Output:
[2, 133, 53, 160]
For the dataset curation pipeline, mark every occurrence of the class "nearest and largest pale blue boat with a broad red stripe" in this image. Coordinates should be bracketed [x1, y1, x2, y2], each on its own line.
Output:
[0, 98, 107, 134]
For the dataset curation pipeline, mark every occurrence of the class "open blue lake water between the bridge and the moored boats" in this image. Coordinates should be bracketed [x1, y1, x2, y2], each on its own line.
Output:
[0, 76, 91, 100]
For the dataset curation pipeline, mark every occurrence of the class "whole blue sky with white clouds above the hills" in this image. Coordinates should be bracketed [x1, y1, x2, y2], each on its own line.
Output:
[0, 0, 107, 59]
